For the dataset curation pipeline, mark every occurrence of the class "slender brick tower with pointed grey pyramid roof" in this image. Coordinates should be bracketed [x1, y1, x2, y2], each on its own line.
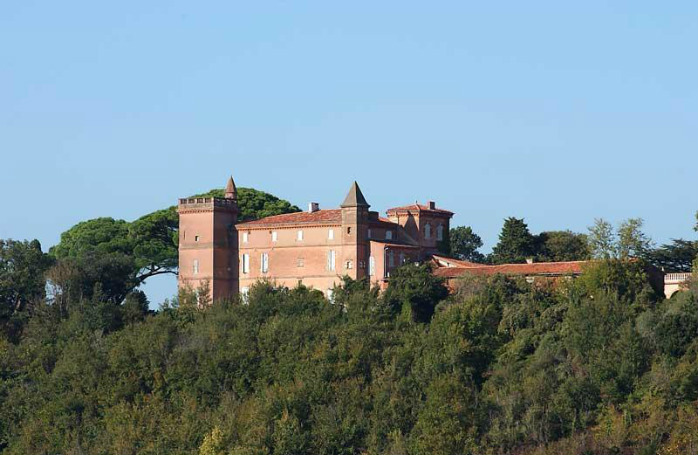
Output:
[340, 182, 371, 280]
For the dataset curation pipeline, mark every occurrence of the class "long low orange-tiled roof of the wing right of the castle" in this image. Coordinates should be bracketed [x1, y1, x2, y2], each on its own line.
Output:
[434, 261, 589, 278]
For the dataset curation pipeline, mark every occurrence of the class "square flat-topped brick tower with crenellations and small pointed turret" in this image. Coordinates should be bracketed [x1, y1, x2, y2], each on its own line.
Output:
[177, 177, 239, 300]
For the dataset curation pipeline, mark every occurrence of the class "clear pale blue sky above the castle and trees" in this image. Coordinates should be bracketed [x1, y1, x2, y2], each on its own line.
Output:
[0, 0, 698, 303]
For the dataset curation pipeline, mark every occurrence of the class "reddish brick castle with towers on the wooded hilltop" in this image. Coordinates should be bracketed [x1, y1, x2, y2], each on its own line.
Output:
[178, 177, 453, 299]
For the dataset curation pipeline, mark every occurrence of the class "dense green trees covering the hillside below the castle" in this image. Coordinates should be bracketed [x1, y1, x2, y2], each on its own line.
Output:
[0, 194, 698, 455]
